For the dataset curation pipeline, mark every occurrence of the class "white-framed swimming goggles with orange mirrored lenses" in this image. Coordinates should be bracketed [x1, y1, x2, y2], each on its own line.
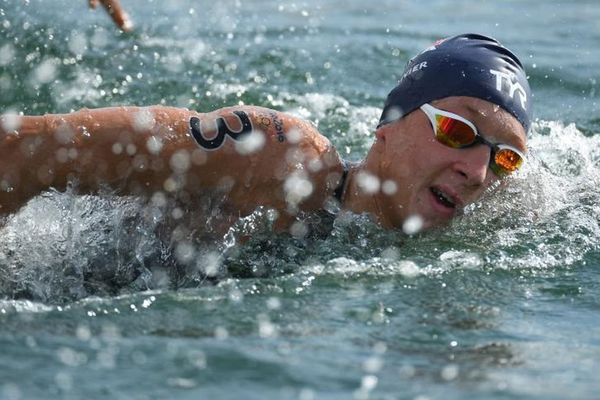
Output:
[421, 103, 525, 177]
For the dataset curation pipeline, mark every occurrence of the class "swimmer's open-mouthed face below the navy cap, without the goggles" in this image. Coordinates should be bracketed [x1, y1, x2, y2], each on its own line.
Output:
[374, 97, 526, 228]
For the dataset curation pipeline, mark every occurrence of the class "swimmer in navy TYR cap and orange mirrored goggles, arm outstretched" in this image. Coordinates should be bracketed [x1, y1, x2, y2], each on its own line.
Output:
[0, 34, 531, 236]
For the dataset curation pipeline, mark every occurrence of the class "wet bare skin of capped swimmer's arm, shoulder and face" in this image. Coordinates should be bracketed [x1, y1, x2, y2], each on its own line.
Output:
[0, 97, 526, 230]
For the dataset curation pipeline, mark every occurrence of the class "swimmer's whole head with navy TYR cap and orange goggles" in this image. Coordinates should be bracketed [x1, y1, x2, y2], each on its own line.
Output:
[356, 34, 531, 228]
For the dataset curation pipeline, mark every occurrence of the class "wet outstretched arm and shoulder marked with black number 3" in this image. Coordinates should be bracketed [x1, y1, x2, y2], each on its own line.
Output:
[0, 106, 341, 225]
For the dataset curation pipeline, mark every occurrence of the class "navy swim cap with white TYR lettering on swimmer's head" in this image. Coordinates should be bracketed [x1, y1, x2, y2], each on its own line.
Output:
[379, 34, 531, 132]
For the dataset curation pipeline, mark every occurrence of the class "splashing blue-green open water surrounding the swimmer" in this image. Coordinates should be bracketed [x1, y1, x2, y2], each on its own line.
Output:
[0, 0, 600, 400]
